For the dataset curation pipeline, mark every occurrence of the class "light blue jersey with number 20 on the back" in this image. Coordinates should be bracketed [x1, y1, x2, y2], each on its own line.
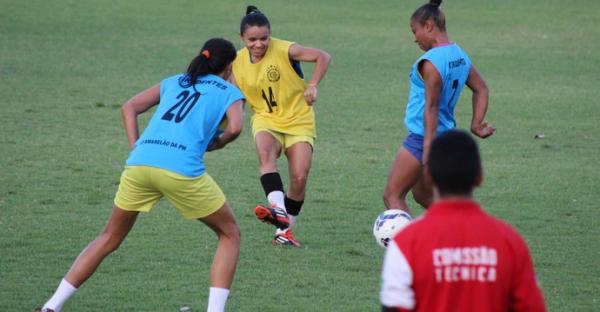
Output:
[126, 74, 244, 177]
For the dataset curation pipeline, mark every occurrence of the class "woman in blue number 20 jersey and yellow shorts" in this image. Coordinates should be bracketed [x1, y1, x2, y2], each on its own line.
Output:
[39, 38, 244, 312]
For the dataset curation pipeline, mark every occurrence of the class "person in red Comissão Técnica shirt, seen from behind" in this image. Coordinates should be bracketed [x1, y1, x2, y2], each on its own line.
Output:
[380, 130, 546, 312]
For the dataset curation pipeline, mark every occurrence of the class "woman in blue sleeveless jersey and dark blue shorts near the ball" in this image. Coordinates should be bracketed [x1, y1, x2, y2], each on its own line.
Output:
[383, 0, 495, 213]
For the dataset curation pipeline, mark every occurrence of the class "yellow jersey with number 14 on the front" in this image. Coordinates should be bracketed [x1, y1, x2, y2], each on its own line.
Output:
[233, 37, 316, 137]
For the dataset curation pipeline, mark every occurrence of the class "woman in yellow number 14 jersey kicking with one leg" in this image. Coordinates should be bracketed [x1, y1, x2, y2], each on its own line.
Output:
[231, 6, 331, 246]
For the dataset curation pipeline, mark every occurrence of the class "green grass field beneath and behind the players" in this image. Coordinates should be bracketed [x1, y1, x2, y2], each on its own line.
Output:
[0, 0, 600, 311]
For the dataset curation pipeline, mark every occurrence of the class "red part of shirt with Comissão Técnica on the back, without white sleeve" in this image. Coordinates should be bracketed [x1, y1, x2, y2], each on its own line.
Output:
[384, 200, 545, 311]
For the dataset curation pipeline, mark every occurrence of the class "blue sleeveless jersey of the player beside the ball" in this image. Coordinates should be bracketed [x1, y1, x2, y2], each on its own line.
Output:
[404, 44, 471, 136]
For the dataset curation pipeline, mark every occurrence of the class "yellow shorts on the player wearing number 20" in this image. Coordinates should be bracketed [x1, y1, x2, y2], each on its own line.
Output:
[114, 166, 225, 219]
